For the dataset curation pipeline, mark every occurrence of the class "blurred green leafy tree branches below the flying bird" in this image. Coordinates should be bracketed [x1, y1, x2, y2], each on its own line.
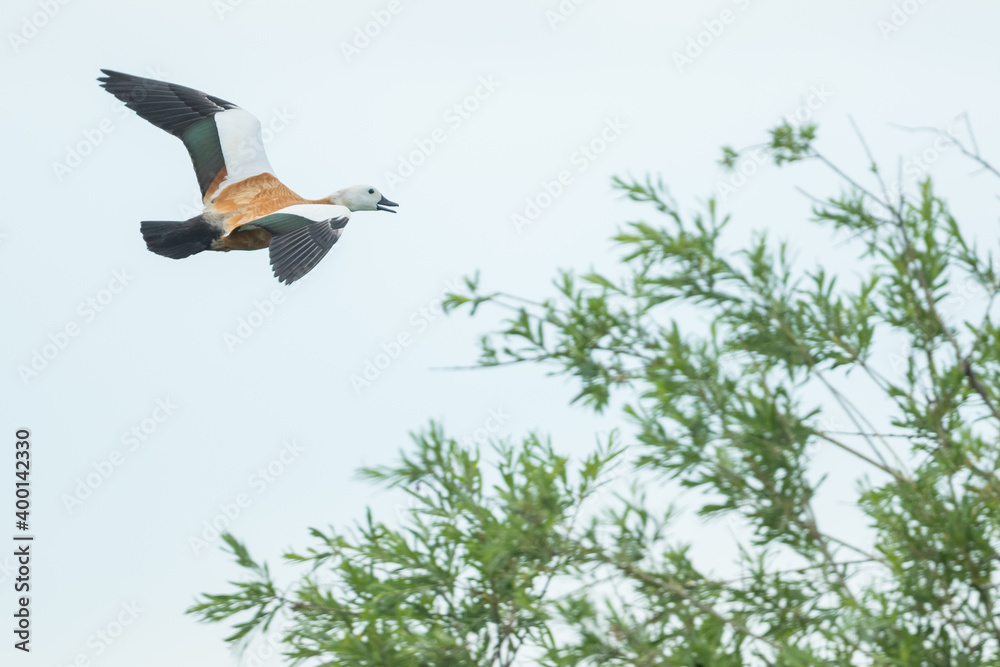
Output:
[190, 125, 1000, 666]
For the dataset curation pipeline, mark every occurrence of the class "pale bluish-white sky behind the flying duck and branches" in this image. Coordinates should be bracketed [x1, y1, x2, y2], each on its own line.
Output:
[0, 0, 1000, 667]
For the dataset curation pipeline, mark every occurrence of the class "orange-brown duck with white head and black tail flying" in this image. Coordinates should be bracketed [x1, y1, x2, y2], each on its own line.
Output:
[98, 69, 397, 284]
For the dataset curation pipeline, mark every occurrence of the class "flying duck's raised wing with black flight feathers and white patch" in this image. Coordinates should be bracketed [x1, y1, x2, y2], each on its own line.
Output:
[98, 69, 273, 197]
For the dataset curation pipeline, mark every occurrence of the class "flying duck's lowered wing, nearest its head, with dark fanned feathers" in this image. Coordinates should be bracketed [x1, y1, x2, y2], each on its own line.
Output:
[239, 204, 351, 285]
